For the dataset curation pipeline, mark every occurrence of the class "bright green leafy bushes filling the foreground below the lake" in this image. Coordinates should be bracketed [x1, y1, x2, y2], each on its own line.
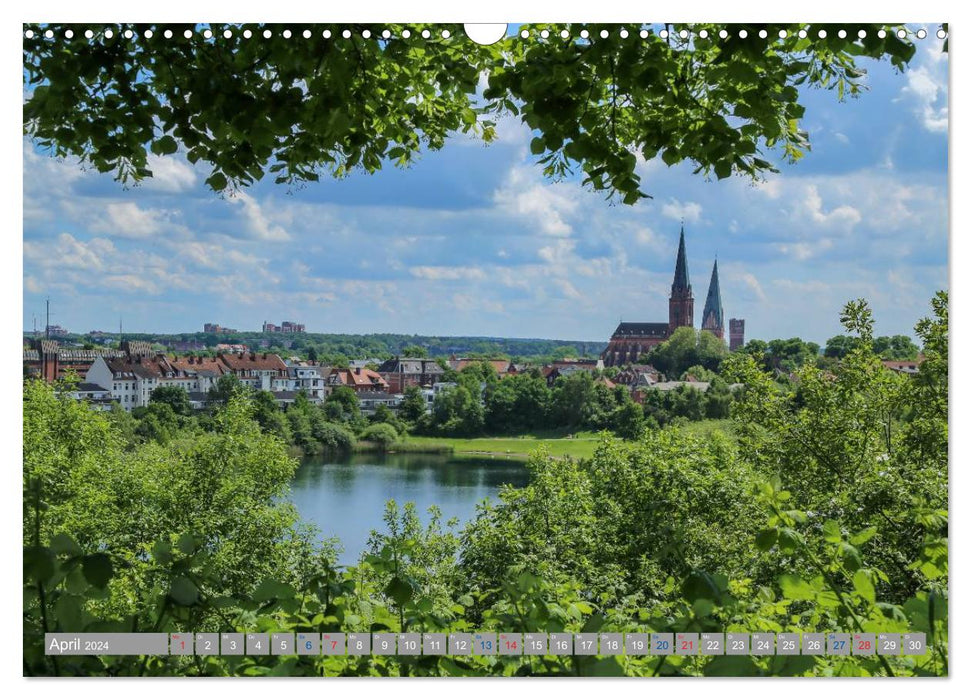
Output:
[23, 293, 948, 676]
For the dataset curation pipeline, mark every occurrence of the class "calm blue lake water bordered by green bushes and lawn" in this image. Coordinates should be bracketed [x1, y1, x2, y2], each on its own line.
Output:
[290, 454, 528, 564]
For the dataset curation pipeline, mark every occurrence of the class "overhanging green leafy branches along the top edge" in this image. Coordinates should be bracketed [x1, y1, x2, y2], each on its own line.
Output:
[23, 24, 915, 203]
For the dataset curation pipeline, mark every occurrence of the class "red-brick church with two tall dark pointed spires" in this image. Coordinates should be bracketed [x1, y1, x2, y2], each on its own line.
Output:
[601, 224, 745, 367]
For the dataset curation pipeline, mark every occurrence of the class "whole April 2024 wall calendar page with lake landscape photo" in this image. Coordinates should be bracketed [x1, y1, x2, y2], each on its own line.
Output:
[21, 20, 950, 688]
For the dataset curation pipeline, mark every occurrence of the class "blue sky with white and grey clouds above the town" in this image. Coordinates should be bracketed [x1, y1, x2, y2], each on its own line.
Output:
[23, 30, 948, 342]
